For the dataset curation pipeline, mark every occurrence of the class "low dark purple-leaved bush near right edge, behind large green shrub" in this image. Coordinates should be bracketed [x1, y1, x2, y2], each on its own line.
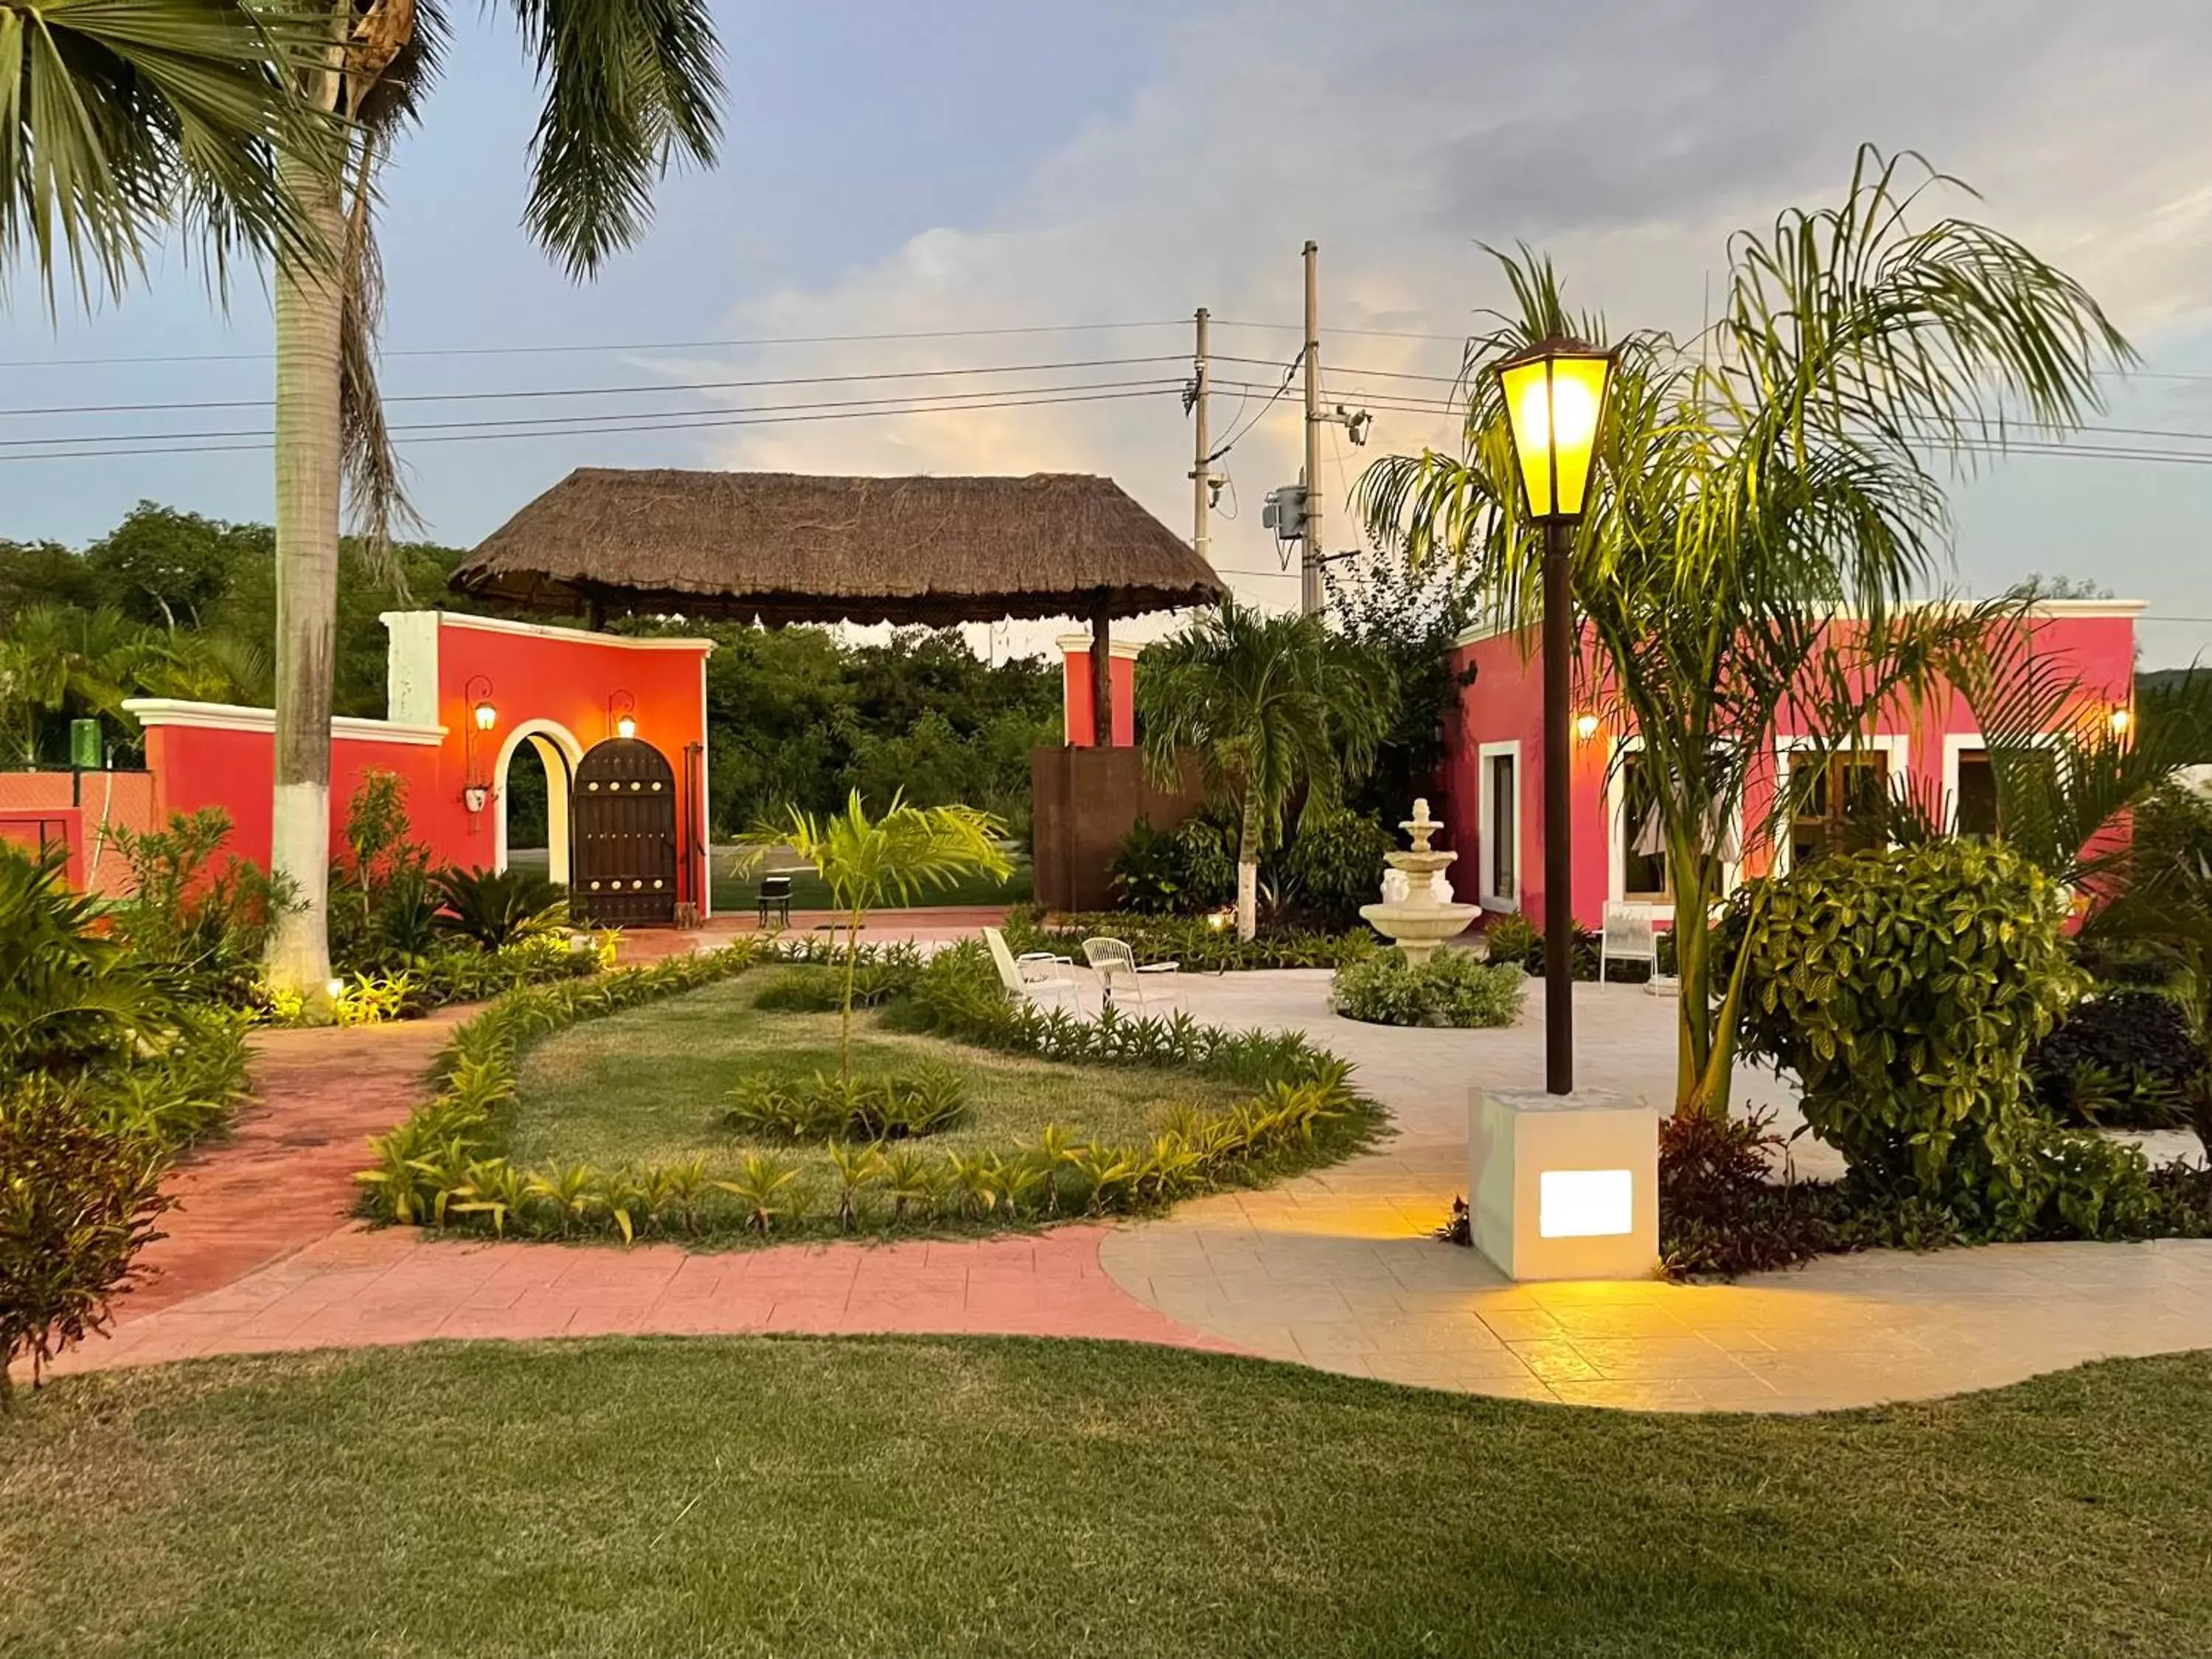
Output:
[2028, 991, 2212, 1128]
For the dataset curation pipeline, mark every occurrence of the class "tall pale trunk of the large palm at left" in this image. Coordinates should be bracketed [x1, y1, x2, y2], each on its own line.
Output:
[268, 55, 345, 1011]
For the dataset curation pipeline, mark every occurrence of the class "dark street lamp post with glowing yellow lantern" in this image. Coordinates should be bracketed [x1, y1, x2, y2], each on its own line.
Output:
[1498, 338, 1613, 1095]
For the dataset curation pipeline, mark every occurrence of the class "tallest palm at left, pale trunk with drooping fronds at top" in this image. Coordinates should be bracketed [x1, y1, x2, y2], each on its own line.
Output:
[268, 0, 721, 1002]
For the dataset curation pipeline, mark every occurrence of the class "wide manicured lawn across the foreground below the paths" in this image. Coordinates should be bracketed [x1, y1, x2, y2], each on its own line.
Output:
[0, 1338, 2212, 1659]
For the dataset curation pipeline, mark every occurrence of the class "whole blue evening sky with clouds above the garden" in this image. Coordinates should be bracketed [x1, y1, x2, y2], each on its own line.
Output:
[0, 0, 2212, 668]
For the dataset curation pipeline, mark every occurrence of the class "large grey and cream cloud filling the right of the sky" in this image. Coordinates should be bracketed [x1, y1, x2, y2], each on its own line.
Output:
[679, 0, 2212, 650]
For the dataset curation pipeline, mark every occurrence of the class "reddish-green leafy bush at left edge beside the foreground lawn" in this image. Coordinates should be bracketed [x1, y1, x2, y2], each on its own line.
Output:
[0, 1077, 168, 1407]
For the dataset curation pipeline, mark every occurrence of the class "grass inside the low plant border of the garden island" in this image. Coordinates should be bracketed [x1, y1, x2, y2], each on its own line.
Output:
[509, 971, 1250, 1172]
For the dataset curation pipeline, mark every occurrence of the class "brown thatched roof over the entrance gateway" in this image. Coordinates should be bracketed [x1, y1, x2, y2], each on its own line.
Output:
[451, 467, 1225, 626]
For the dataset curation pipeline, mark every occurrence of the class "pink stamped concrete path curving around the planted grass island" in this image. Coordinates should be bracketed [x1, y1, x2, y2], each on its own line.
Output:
[53, 1011, 1230, 1371]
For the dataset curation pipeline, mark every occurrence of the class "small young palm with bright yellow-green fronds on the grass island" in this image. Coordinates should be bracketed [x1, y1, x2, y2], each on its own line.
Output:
[743, 790, 1013, 1082]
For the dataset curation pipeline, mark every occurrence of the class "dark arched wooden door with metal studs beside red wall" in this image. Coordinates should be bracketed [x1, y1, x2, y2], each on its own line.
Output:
[568, 737, 677, 927]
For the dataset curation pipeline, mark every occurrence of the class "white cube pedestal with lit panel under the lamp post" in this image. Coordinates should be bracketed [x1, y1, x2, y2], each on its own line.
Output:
[1467, 1091, 1659, 1279]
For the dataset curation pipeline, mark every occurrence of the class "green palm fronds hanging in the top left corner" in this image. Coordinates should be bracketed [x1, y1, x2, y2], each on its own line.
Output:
[0, 0, 330, 307]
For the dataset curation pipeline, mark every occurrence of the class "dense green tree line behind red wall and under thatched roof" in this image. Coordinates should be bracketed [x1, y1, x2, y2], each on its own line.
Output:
[0, 502, 1062, 845]
